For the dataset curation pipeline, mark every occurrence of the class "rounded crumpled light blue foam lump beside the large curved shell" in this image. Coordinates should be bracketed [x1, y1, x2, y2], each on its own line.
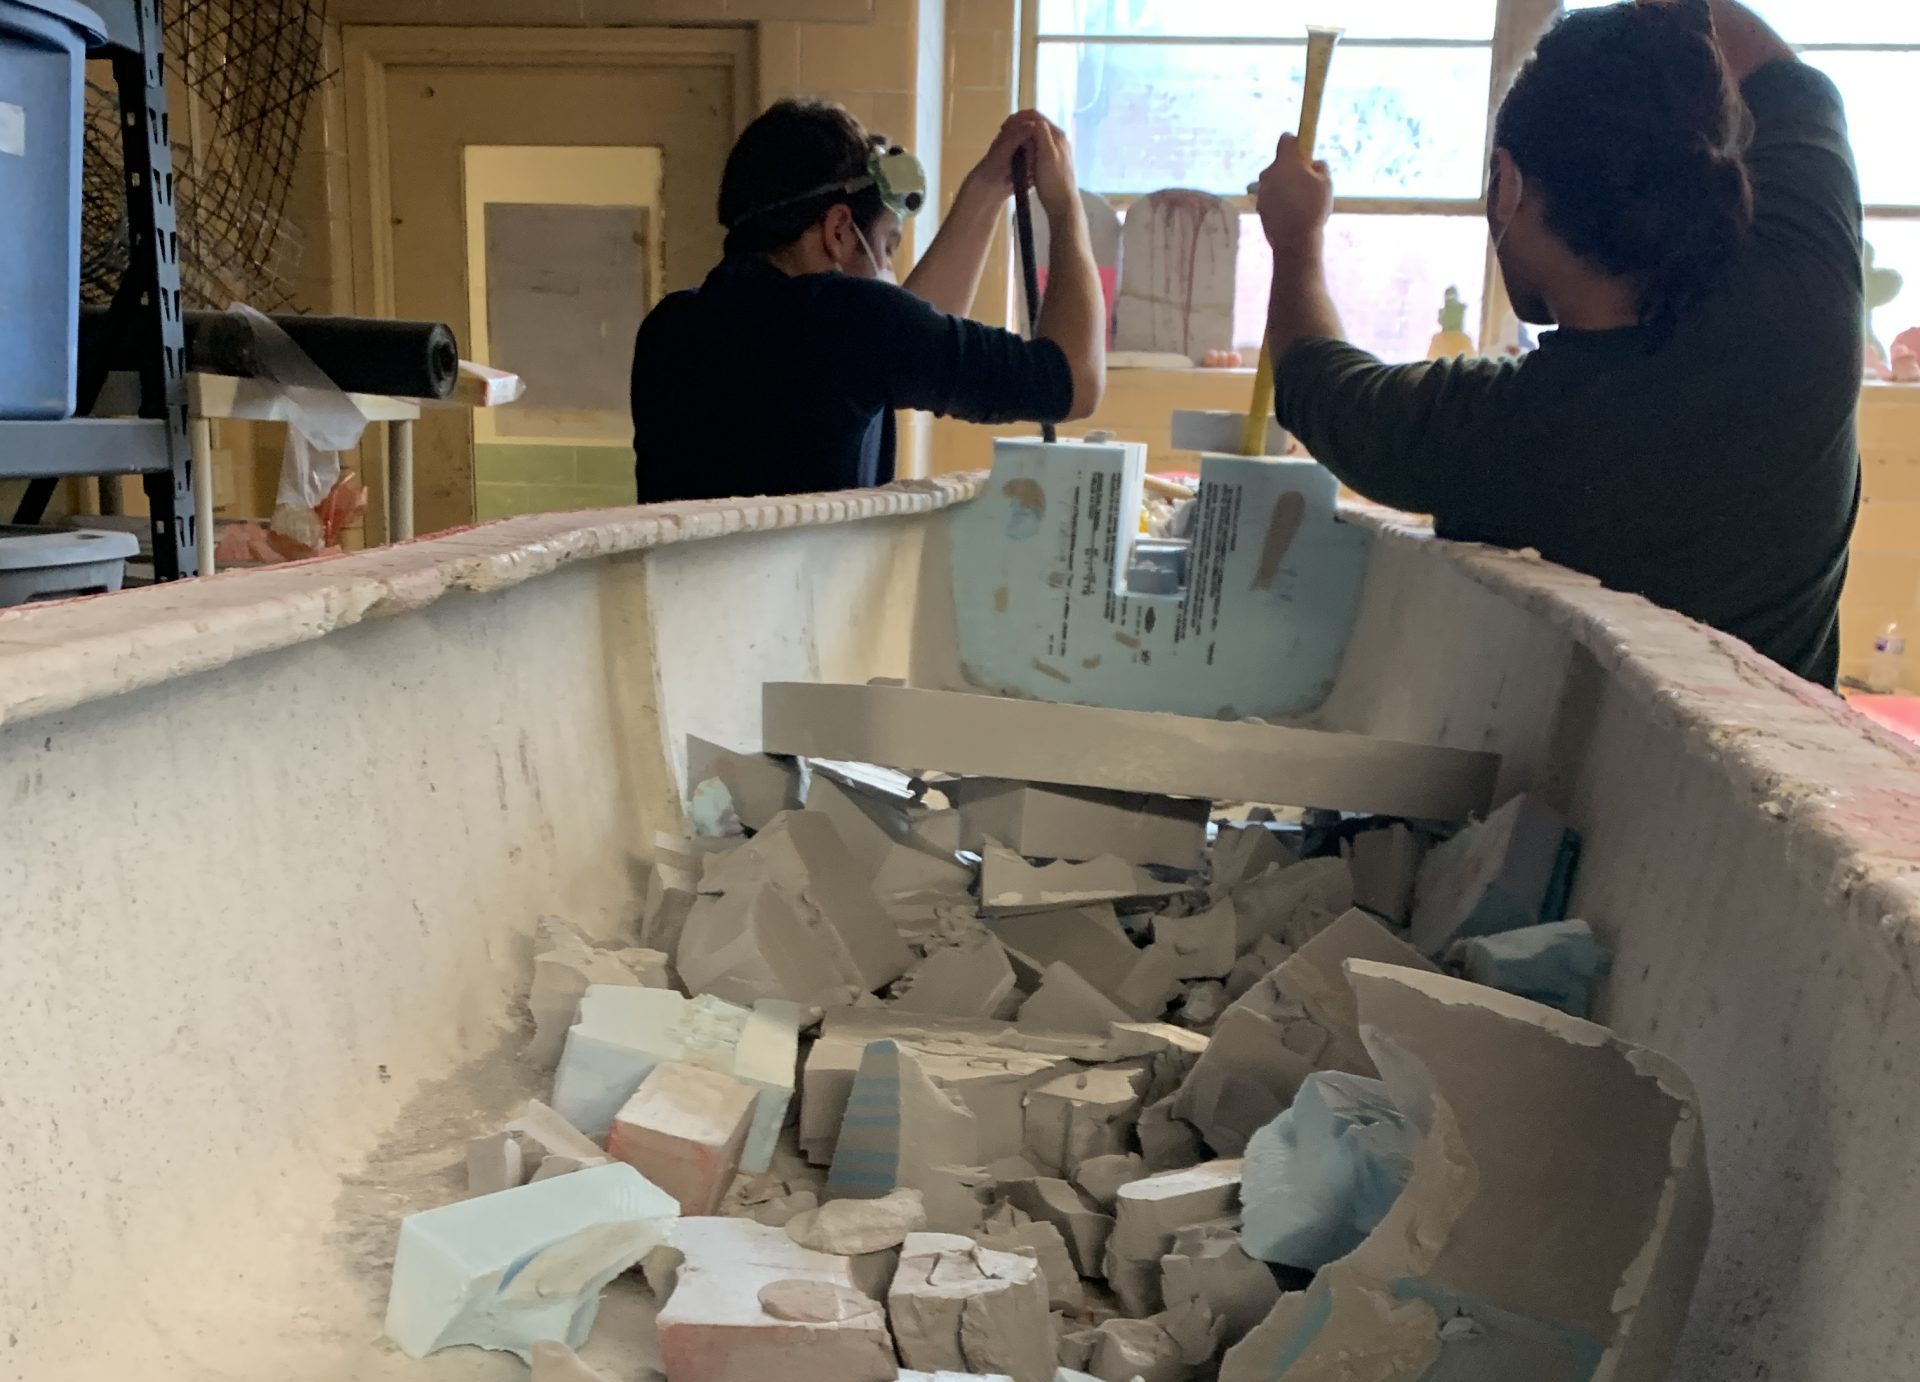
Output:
[1240, 1071, 1413, 1271]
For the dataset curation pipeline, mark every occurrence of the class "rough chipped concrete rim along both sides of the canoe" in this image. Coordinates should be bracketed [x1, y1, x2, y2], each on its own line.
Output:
[0, 474, 1920, 967]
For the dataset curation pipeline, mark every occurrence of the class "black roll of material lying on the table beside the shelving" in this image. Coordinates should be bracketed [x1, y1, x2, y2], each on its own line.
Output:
[81, 307, 461, 399]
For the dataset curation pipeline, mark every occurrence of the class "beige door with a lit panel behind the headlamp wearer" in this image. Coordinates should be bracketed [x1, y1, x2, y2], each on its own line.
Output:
[346, 27, 755, 534]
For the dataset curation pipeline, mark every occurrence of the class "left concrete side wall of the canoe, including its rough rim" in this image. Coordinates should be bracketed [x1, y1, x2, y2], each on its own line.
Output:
[0, 486, 966, 1382]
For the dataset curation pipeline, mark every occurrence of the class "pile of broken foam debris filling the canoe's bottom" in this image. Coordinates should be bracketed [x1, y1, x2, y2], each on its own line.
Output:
[388, 691, 1711, 1382]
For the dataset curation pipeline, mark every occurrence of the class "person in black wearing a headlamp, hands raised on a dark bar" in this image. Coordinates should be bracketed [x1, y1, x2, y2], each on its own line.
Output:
[632, 100, 1106, 503]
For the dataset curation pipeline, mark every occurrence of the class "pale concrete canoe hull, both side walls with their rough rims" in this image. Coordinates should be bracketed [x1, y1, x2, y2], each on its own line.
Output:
[0, 486, 1920, 1382]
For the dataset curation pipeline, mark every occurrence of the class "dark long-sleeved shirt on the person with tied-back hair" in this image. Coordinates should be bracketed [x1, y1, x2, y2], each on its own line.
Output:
[1275, 61, 1864, 685]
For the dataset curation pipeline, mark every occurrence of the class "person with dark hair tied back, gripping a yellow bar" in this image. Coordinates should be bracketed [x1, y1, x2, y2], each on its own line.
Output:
[1260, 0, 1864, 685]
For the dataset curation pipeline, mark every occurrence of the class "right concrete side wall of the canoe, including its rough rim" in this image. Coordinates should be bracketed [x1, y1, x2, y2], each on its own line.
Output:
[1325, 534, 1920, 1382]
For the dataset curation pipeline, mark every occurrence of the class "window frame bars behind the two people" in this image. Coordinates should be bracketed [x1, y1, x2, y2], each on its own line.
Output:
[1016, 0, 1920, 349]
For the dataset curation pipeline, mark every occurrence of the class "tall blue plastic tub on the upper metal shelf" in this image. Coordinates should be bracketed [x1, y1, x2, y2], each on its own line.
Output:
[0, 0, 106, 418]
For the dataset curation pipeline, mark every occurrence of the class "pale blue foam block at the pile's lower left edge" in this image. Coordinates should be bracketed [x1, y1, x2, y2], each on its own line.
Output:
[386, 1161, 680, 1363]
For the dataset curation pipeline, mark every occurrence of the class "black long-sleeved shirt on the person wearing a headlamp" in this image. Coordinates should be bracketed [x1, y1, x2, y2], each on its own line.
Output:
[632, 257, 1073, 503]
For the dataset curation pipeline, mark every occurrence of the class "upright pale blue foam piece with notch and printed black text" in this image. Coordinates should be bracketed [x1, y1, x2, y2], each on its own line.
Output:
[952, 440, 1373, 718]
